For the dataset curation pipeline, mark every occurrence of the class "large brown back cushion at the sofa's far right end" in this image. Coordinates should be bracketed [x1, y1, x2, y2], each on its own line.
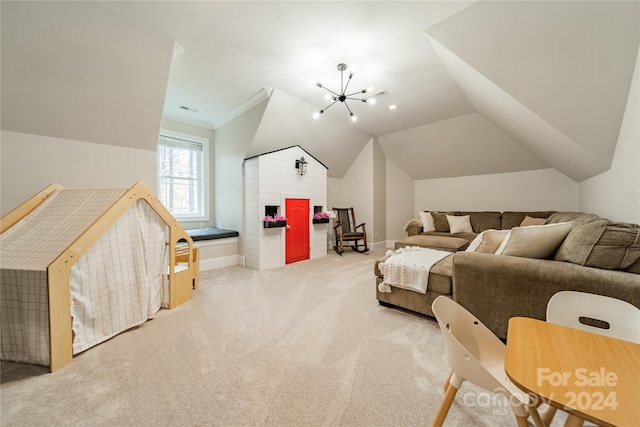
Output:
[555, 219, 640, 270]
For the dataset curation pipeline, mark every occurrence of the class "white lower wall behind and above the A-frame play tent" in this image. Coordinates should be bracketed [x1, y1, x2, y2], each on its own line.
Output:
[0, 130, 157, 215]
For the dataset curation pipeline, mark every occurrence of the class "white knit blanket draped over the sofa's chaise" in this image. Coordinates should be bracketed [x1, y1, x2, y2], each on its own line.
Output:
[378, 246, 451, 294]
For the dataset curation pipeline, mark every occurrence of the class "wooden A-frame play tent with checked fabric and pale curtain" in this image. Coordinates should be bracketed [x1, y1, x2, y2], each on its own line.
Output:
[0, 182, 199, 372]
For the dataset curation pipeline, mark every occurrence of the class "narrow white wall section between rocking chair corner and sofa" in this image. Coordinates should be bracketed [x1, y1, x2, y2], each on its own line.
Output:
[386, 160, 418, 246]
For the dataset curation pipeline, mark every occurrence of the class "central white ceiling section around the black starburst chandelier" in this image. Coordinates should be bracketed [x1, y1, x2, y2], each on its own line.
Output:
[104, 1, 473, 135]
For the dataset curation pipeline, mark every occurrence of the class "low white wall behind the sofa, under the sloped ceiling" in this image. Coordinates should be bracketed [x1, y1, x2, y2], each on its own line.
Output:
[407, 169, 579, 213]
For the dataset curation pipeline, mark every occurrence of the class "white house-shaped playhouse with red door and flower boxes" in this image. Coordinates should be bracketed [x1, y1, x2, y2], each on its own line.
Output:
[244, 145, 330, 270]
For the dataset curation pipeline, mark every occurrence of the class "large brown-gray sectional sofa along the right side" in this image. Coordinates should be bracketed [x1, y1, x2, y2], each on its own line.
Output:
[374, 211, 640, 339]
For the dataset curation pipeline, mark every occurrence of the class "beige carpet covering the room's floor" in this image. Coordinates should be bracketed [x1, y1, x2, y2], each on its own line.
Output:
[0, 251, 564, 427]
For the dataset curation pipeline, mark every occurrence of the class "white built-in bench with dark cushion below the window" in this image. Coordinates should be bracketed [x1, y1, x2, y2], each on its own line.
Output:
[187, 227, 244, 271]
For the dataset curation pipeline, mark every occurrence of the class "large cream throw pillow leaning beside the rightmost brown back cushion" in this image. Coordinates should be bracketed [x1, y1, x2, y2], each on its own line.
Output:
[496, 222, 573, 259]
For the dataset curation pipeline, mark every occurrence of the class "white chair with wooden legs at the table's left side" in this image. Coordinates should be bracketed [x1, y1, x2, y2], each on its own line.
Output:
[431, 296, 544, 427]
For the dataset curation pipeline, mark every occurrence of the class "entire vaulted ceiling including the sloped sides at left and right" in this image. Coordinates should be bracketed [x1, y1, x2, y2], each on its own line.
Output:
[1, 1, 640, 181]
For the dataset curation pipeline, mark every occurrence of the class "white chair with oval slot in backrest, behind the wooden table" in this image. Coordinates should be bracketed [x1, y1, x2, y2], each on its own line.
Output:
[542, 291, 640, 426]
